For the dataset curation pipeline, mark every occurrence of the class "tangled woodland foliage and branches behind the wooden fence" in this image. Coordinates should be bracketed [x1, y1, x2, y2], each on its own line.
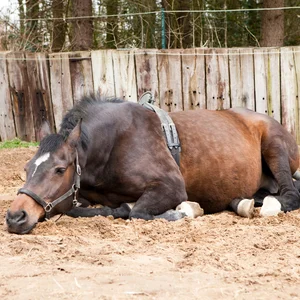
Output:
[1, 0, 300, 51]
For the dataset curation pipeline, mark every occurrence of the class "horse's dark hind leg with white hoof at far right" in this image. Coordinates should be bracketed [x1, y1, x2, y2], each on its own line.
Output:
[260, 142, 300, 216]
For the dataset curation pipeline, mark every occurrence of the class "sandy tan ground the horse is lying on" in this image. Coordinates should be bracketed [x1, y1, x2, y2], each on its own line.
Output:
[0, 148, 300, 300]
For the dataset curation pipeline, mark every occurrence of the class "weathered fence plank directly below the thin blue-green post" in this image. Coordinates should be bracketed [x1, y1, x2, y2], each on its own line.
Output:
[157, 49, 183, 111]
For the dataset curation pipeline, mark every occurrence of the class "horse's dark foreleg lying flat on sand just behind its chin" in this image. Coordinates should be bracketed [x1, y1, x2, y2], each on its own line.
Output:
[66, 203, 131, 219]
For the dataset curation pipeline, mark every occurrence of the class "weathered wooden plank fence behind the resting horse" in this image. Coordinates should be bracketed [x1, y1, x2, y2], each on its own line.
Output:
[0, 47, 300, 143]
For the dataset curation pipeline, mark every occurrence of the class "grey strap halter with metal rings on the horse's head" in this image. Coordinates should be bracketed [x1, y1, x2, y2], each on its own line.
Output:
[18, 150, 81, 220]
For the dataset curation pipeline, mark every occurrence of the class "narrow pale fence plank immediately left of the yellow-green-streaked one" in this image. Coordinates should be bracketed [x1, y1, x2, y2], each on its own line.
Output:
[254, 48, 268, 114]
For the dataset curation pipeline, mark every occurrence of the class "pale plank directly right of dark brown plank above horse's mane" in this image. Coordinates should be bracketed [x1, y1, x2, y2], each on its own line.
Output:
[91, 50, 116, 97]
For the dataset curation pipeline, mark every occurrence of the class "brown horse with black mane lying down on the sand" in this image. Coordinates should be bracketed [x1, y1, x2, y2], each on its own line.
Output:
[6, 96, 300, 233]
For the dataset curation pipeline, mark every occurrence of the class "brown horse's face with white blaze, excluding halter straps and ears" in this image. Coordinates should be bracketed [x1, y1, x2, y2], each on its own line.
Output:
[6, 120, 81, 234]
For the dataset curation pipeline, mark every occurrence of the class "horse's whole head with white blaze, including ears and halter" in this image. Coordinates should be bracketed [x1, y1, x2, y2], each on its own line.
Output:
[6, 121, 81, 234]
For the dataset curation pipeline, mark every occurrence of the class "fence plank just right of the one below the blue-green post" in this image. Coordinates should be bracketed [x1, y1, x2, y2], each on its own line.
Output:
[181, 49, 206, 110]
